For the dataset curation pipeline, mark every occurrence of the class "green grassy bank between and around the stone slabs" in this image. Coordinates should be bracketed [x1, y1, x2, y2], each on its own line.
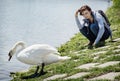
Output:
[11, 0, 120, 81]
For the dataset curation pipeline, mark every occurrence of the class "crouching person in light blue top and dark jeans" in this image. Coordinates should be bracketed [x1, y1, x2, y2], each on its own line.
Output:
[75, 5, 112, 46]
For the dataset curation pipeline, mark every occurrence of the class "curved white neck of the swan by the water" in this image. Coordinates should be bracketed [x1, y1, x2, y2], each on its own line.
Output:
[13, 42, 25, 53]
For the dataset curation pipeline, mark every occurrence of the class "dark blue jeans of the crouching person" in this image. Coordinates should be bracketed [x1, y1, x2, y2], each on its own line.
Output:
[80, 24, 110, 43]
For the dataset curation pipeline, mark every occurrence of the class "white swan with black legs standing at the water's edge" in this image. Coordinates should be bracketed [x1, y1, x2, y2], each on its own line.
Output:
[8, 41, 70, 75]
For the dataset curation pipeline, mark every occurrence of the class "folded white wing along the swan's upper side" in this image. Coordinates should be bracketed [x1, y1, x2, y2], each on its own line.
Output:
[22, 44, 59, 56]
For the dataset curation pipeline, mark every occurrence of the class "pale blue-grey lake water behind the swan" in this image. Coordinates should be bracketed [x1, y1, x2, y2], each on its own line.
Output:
[0, 0, 109, 81]
